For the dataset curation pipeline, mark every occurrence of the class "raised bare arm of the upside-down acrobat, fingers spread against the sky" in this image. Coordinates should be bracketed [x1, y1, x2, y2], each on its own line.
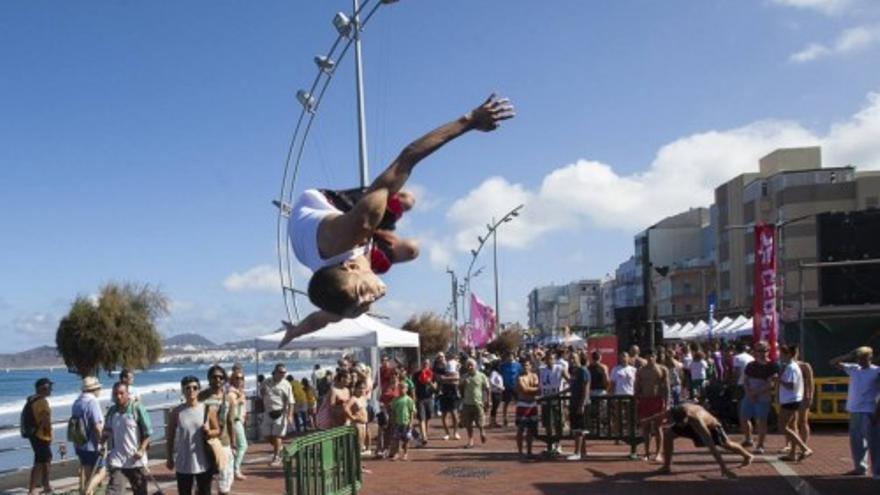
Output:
[319, 94, 514, 253]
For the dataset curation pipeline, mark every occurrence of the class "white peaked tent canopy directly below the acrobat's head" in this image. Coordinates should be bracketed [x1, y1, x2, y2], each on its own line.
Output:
[256, 315, 419, 350]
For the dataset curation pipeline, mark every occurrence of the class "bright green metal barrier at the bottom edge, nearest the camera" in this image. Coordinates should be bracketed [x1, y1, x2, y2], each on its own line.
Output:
[283, 426, 362, 495]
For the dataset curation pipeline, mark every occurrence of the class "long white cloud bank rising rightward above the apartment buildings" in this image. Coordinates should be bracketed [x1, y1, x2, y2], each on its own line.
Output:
[447, 93, 880, 247]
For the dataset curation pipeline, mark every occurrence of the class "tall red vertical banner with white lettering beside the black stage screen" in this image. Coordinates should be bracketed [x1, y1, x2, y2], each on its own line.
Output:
[752, 223, 779, 360]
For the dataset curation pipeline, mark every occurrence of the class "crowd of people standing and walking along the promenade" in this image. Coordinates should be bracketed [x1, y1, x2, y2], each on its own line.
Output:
[21, 342, 880, 494]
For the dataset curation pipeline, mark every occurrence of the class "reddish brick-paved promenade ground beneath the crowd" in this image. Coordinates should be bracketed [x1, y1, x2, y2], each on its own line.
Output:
[12, 427, 880, 495]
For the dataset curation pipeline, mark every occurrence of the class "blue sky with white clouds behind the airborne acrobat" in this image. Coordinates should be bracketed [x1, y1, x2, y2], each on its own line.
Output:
[0, 0, 880, 351]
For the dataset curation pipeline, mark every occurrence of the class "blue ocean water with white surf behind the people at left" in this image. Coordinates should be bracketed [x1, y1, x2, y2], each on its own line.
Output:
[0, 360, 332, 474]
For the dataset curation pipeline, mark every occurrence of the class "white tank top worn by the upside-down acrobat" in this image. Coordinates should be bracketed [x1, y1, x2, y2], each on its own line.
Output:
[287, 189, 366, 272]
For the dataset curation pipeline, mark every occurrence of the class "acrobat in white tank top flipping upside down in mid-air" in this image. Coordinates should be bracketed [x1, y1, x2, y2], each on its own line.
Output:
[279, 94, 514, 346]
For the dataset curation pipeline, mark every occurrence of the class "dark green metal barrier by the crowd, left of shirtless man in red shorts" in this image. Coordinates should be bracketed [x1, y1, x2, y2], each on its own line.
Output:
[537, 391, 643, 459]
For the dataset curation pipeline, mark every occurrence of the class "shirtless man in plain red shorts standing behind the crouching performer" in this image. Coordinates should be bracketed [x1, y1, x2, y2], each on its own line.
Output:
[635, 349, 669, 462]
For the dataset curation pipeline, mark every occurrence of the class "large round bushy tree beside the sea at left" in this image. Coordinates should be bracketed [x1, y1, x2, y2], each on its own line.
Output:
[55, 282, 168, 377]
